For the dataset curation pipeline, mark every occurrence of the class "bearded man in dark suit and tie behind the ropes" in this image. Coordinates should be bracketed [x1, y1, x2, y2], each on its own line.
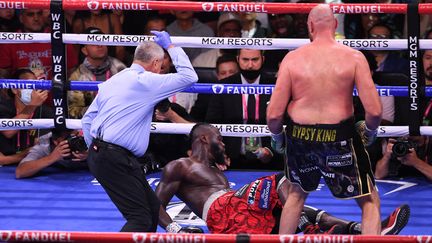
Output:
[206, 49, 282, 169]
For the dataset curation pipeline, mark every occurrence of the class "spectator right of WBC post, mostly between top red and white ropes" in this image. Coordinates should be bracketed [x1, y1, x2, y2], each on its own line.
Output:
[72, 10, 126, 62]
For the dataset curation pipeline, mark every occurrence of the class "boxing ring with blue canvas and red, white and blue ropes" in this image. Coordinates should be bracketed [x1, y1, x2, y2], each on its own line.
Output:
[0, 0, 432, 242]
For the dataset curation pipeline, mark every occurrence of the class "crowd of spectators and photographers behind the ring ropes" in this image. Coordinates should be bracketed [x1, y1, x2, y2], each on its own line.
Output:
[0, 0, 432, 180]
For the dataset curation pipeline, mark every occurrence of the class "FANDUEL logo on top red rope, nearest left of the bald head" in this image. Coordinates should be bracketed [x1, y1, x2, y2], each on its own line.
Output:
[201, 3, 267, 13]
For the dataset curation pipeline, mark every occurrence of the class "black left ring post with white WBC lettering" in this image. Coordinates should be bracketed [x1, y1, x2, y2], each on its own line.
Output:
[51, 0, 68, 129]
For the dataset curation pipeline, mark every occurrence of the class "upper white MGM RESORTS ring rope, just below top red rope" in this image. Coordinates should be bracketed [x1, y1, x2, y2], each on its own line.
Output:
[0, 32, 432, 50]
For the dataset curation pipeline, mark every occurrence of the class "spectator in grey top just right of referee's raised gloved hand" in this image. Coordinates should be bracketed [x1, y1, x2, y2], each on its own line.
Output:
[167, 11, 214, 60]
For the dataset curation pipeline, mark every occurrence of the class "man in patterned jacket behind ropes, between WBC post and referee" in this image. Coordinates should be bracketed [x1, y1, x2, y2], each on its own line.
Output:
[68, 27, 126, 119]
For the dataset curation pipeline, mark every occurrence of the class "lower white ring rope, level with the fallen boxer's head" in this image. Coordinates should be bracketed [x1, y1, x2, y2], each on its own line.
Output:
[0, 119, 432, 137]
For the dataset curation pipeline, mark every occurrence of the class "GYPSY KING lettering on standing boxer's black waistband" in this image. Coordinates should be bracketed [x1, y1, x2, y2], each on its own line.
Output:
[291, 125, 337, 142]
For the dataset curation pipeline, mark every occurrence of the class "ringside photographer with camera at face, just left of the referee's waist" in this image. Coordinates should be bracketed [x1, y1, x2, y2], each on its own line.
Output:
[15, 129, 88, 179]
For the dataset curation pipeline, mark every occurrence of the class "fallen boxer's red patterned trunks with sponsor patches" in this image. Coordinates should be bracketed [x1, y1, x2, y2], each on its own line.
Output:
[204, 174, 285, 234]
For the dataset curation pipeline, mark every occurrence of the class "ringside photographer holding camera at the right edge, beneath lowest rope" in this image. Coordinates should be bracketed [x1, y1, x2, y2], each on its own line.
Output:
[375, 136, 432, 180]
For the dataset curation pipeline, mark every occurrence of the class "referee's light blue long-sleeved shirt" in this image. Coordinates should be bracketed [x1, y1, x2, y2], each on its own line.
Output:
[81, 47, 198, 157]
